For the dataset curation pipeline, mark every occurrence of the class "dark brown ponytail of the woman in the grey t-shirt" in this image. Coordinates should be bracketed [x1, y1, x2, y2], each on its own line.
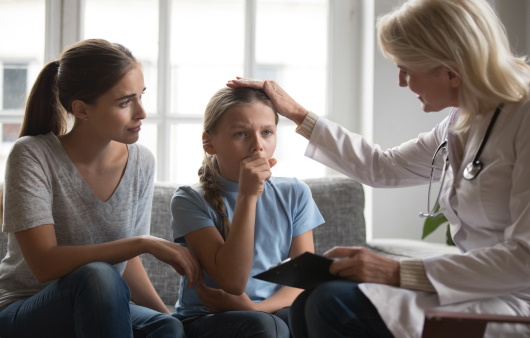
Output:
[18, 61, 66, 137]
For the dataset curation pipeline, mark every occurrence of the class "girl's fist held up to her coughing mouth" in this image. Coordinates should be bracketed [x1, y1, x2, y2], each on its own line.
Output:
[239, 150, 278, 196]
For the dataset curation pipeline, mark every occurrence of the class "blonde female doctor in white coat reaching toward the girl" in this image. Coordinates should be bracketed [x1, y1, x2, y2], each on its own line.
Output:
[227, 0, 530, 337]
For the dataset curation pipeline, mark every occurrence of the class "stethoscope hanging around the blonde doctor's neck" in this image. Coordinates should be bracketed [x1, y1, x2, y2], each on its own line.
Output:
[420, 103, 503, 217]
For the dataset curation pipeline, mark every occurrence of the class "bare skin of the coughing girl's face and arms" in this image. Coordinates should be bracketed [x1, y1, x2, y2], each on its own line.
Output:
[185, 103, 314, 313]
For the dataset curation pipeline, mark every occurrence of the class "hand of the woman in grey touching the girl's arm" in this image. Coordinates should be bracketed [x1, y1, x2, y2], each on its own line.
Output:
[142, 236, 203, 288]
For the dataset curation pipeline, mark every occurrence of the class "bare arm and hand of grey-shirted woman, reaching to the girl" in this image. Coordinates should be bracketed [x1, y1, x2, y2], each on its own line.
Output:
[15, 224, 201, 286]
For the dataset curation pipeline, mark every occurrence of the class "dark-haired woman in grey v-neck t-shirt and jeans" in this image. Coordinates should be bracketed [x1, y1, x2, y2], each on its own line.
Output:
[0, 40, 200, 338]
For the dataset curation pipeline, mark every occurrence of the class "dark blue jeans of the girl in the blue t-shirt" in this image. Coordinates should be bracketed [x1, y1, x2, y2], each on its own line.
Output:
[182, 308, 290, 338]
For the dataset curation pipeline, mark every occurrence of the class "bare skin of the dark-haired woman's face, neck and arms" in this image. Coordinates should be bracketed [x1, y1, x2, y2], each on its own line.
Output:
[15, 66, 202, 313]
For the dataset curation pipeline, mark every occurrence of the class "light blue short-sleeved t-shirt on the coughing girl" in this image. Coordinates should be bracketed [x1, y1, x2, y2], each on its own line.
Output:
[171, 176, 324, 318]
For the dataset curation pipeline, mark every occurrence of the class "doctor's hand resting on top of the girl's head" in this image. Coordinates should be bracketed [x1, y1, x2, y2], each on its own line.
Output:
[226, 77, 307, 125]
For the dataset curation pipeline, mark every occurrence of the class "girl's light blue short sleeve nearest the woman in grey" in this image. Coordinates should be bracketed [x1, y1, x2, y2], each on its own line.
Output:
[171, 186, 220, 243]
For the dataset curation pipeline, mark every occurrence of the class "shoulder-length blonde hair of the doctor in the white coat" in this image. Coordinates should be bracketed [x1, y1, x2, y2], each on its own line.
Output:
[377, 0, 530, 131]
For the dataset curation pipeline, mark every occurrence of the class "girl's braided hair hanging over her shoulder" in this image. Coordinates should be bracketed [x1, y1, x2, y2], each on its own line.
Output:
[199, 155, 230, 241]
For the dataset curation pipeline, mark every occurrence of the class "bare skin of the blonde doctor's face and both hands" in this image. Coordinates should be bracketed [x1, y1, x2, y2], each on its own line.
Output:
[227, 65, 462, 286]
